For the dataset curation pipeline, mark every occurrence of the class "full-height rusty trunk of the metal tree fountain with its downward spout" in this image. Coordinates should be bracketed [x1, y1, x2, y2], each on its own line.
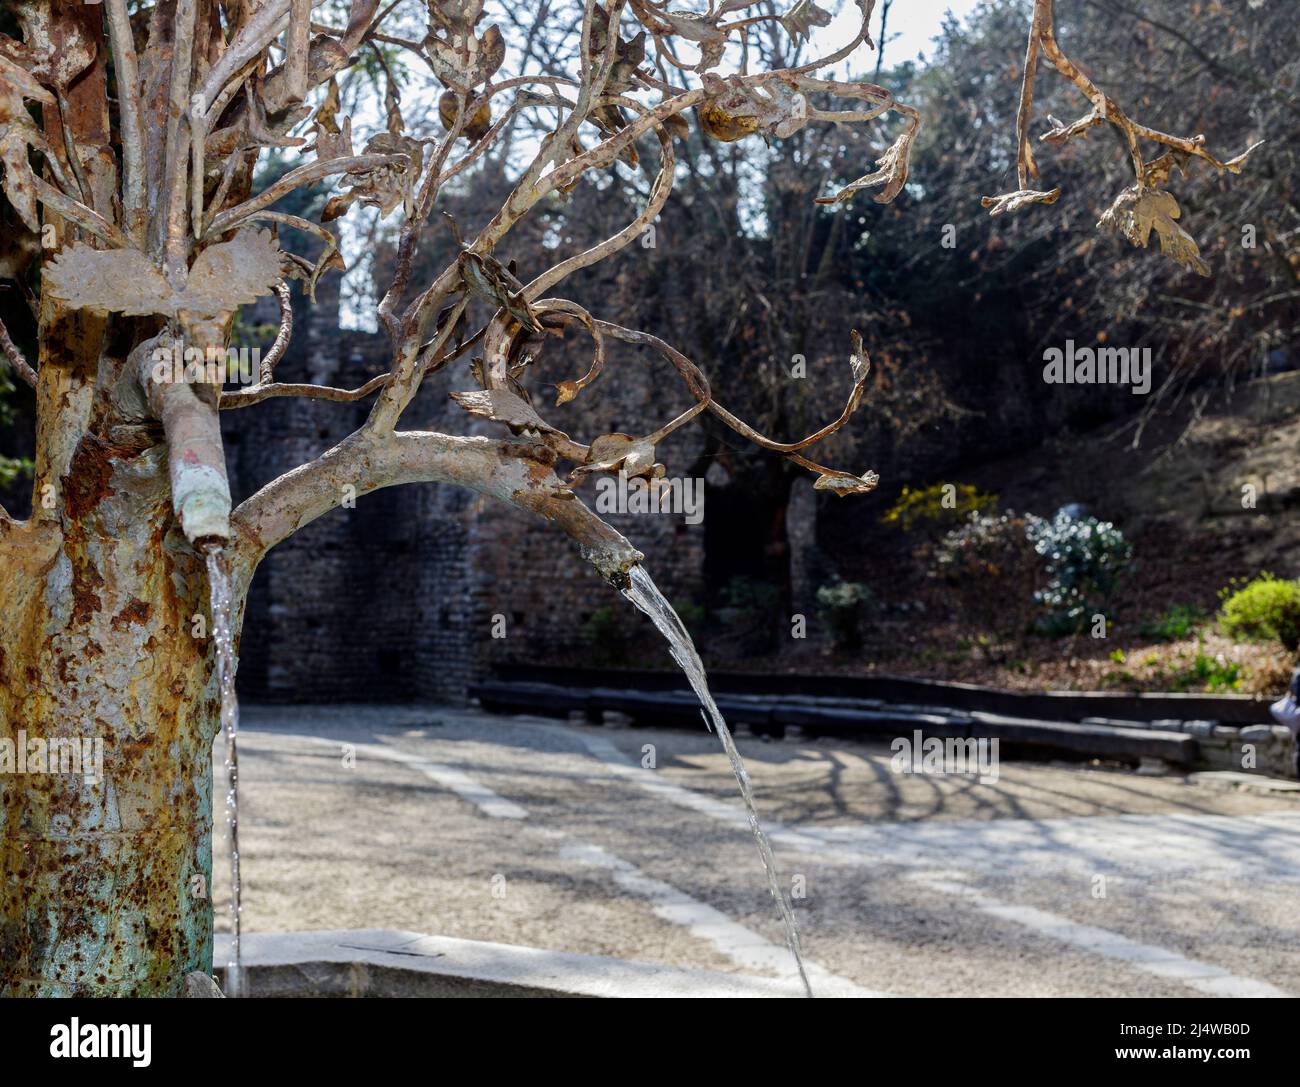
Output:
[0, 3, 250, 996]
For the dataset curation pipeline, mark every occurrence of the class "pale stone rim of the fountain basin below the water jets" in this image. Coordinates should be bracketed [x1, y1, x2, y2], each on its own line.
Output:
[213, 928, 802, 997]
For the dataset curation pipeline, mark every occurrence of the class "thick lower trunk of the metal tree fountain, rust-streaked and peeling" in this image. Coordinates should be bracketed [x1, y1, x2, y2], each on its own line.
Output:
[0, 348, 247, 995]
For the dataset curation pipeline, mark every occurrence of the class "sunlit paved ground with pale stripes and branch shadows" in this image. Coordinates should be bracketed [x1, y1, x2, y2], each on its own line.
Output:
[215, 706, 1300, 996]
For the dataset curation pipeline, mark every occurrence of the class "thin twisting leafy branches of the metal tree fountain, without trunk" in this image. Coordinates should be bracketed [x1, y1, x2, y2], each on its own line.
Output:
[0, 0, 1244, 561]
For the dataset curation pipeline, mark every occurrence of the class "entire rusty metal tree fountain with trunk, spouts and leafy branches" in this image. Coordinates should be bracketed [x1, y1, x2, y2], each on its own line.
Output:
[0, 0, 1258, 995]
